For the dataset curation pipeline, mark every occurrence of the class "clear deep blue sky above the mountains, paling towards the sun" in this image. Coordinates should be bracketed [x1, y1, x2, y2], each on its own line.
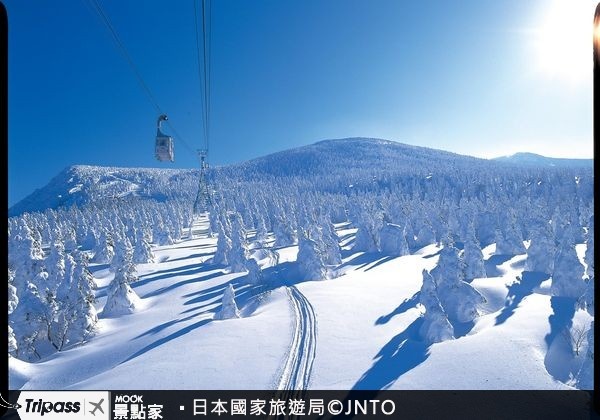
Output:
[4, 0, 593, 206]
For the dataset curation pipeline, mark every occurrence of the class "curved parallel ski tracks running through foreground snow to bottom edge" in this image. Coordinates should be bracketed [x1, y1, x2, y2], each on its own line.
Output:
[277, 286, 317, 391]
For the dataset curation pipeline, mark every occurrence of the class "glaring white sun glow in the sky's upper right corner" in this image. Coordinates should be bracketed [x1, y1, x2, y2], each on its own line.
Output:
[534, 0, 598, 84]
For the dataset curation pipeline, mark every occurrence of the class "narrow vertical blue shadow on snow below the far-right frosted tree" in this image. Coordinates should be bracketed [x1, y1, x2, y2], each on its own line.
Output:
[544, 296, 577, 382]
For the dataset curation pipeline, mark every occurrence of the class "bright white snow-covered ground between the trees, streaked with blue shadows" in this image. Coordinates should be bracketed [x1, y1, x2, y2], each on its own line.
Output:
[10, 221, 592, 389]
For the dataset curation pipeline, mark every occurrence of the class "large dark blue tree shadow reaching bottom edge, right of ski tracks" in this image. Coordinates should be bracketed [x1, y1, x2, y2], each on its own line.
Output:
[352, 317, 430, 391]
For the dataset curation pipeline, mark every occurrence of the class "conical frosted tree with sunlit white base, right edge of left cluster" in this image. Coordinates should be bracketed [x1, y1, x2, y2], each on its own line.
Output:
[102, 248, 141, 317]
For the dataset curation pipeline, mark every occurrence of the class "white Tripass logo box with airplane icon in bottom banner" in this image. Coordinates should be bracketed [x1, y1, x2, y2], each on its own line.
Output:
[17, 391, 110, 420]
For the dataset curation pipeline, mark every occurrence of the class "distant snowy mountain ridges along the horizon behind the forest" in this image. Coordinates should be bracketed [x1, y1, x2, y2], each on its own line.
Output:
[9, 138, 592, 216]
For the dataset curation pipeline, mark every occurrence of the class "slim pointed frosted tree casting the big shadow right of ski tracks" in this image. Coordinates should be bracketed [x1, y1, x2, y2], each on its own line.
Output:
[419, 270, 454, 344]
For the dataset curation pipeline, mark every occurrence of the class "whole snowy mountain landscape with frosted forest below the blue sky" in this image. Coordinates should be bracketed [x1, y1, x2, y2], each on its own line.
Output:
[8, 139, 594, 390]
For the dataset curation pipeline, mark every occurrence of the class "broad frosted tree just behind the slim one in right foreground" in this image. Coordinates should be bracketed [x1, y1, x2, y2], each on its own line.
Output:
[431, 237, 485, 322]
